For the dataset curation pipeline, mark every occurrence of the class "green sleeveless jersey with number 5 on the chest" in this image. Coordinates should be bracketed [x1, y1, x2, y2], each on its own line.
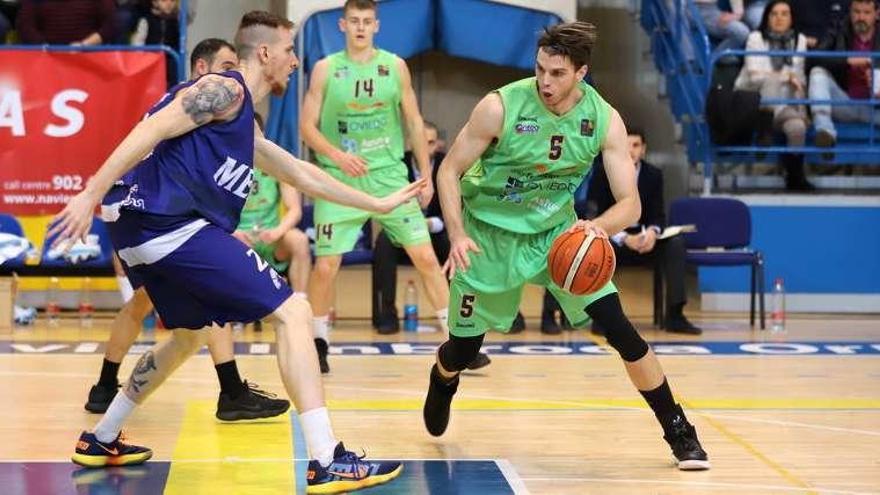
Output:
[461, 77, 611, 234]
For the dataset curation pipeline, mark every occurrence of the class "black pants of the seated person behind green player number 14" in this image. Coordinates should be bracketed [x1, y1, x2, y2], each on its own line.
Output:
[373, 230, 449, 326]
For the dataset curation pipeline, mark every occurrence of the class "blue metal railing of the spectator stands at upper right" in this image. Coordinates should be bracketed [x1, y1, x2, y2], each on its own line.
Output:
[642, 0, 880, 193]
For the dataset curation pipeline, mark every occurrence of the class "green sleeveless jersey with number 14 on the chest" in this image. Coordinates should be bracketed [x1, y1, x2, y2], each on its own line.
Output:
[318, 49, 403, 171]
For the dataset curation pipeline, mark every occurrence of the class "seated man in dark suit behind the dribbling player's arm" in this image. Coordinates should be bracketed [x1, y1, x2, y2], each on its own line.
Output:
[587, 127, 702, 335]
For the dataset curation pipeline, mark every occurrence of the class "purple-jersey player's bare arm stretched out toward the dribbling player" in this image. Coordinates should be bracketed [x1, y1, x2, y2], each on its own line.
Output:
[254, 138, 425, 213]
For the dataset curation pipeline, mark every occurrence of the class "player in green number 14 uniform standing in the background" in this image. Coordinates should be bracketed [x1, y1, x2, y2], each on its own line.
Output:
[300, 0, 449, 373]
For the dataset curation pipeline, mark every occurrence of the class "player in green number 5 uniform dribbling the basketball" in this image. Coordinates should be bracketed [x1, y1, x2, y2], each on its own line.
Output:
[423, 22, 709, 470]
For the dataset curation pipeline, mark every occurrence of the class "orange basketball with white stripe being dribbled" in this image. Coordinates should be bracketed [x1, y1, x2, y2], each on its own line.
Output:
[547, 229, 616, 296]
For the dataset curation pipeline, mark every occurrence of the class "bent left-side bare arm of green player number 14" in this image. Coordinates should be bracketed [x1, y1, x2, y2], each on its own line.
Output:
[299, 59, 367, 177]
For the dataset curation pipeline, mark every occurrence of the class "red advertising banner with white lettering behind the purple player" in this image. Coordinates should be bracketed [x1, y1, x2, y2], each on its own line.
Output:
[0, 50, 165, 215]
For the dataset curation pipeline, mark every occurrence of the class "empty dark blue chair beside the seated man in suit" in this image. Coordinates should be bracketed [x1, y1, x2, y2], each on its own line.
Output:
[669, 198, 765, 330]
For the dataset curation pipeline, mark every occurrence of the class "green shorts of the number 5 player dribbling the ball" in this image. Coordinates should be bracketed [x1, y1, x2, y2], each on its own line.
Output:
[449, 211, 617, 337]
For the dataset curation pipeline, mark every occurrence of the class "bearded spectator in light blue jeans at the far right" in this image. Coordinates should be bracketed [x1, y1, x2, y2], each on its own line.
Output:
[809, 0, 880, 151]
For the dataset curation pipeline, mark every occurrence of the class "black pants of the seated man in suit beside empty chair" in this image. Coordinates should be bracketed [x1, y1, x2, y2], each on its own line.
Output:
[612, 235, 687, 315]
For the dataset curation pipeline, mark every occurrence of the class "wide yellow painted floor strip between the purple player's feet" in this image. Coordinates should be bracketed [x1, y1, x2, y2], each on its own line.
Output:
[165, 400, 296, 495]
